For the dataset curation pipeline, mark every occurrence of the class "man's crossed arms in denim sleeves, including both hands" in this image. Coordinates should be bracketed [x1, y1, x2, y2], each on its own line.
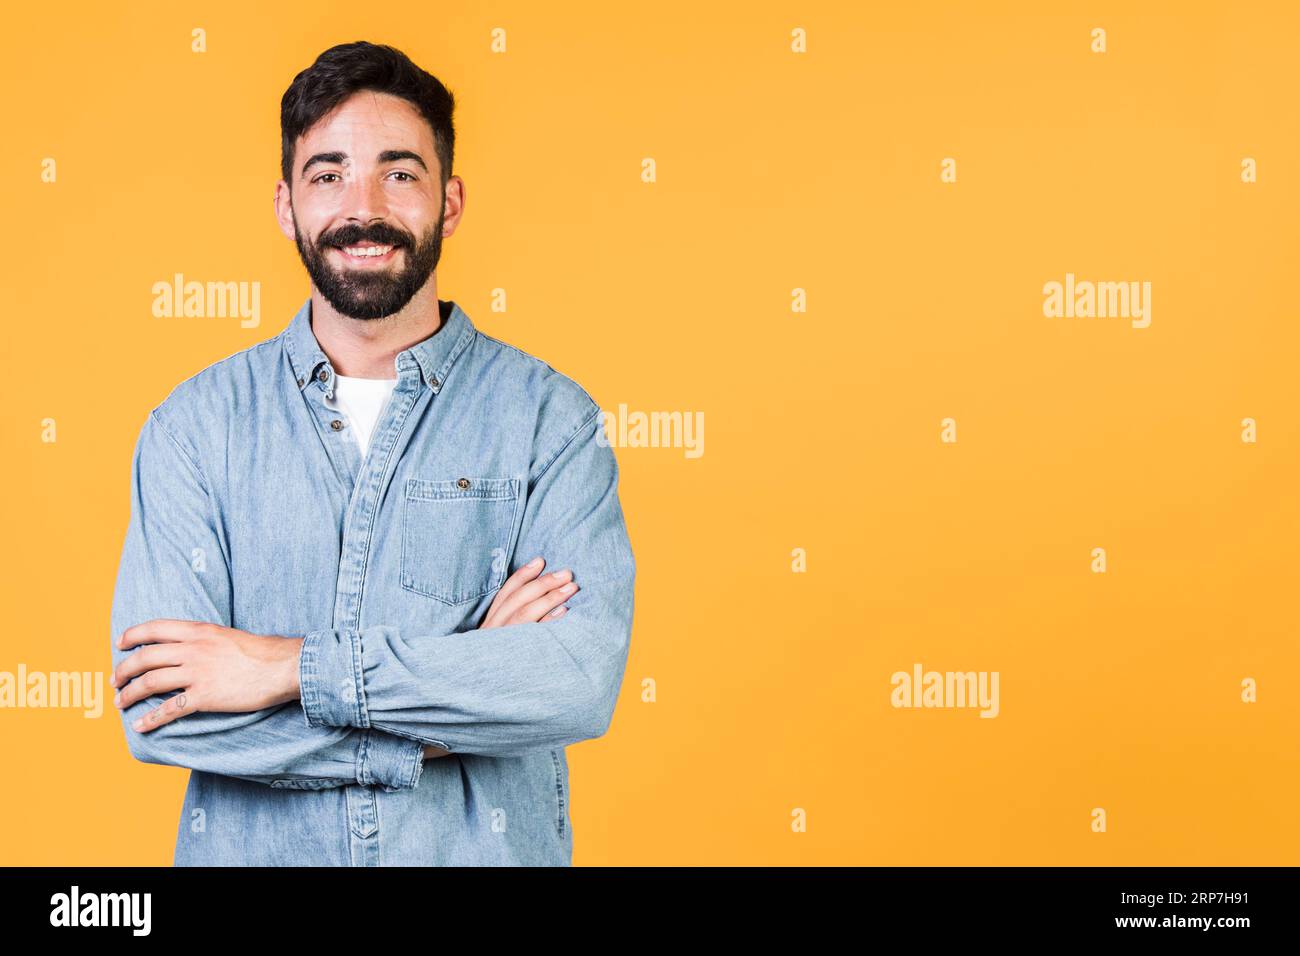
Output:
[111, 408, 636, 791]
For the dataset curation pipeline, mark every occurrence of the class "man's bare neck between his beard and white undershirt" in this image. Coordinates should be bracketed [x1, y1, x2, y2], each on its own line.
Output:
[311, 277, 442, 378]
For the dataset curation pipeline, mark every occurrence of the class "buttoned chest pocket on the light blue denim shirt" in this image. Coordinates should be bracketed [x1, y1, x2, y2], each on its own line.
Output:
[399, 476, 519, 605]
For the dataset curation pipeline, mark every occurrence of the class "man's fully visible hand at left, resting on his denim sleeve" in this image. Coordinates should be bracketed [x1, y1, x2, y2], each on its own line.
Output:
[112, 618, 303, 731]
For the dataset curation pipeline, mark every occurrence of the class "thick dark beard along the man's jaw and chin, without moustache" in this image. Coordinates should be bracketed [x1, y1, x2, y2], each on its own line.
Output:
[294, 209, 446, 319]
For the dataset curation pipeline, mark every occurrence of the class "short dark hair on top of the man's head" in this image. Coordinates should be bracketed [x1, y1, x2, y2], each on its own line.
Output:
[280, 40, 456, 193]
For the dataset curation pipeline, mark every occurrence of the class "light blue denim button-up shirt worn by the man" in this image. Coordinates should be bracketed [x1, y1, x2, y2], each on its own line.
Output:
[111, 299, 636, 866]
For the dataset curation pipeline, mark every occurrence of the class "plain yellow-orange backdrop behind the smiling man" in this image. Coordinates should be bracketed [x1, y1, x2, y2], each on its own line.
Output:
[0, 3, 1300, 865]
